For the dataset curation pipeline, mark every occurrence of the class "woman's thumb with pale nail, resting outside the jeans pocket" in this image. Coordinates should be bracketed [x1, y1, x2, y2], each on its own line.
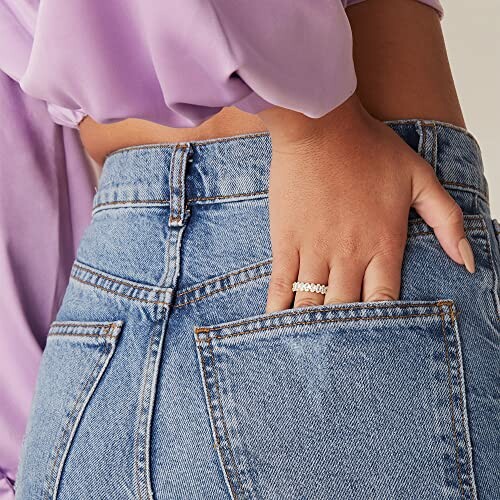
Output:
[412, 162, 475, 273]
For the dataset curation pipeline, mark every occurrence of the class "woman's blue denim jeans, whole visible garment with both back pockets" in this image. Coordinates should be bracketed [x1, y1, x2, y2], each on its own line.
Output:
[17, 120, 500, 500]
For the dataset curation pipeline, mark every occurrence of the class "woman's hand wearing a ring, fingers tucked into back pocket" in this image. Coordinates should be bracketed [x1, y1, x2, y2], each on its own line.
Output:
[259, 94, 474, 312]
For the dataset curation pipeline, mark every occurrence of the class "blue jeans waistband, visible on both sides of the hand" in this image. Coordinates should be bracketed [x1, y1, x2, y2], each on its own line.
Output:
[93, 119, 488, 219]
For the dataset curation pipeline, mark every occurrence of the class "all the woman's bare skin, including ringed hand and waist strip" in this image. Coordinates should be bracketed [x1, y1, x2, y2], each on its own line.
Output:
[80, 0, 474, 312]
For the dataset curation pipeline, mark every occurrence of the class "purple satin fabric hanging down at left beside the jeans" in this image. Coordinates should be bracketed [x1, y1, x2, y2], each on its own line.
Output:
[0, 71, 94, 500]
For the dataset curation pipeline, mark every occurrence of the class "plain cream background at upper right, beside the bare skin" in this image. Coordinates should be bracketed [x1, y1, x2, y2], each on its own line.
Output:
[441, 0, 500, 218]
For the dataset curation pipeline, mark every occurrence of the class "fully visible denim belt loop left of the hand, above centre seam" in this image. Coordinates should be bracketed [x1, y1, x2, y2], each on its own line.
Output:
[168, 142, 191, 226]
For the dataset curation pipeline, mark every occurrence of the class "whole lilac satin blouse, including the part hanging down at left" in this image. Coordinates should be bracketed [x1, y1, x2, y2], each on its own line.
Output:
[0, 0, 443, 494]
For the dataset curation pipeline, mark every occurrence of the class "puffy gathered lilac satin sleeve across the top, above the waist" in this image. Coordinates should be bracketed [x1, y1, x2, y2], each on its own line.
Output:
[11, 0, 356, 127]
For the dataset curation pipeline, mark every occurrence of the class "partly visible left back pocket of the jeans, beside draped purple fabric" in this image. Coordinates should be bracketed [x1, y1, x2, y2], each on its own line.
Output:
[16, 321, 123, 499]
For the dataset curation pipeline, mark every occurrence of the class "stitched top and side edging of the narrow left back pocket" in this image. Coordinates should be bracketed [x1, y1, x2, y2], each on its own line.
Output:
[44, 322, 123, 499]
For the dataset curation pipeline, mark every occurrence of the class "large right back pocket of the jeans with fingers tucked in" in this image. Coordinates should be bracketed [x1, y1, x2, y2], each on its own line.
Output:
[195, 301, 476, 500]
